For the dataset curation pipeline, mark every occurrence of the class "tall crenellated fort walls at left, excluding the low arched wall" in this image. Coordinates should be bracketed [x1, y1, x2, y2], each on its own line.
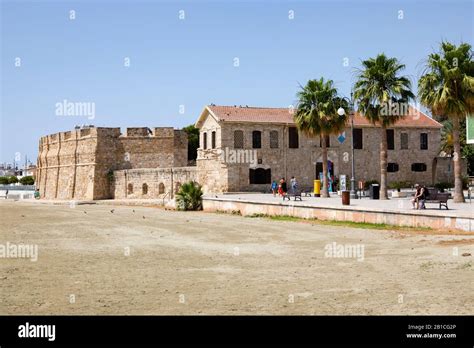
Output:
[37, 127, 187, 200]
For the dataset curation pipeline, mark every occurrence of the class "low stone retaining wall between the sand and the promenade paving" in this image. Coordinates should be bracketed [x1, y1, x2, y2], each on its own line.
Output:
[203, 197, 474, 232]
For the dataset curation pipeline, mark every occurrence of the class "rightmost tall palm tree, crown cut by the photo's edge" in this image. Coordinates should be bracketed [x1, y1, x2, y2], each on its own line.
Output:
[418, 42, 474, 202]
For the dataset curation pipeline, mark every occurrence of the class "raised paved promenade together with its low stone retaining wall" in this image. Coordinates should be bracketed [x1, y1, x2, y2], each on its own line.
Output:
[203, 193, 474, 232]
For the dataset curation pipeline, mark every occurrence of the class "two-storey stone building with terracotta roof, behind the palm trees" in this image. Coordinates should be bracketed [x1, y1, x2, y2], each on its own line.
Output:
[196, 105, 456, 192]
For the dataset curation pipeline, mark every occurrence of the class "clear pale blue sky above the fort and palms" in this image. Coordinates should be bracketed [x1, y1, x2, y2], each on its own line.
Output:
[0, 0, 474, 162]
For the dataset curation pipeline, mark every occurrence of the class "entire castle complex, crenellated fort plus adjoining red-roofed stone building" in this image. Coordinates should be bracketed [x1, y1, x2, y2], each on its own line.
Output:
[36, 105, 462, 200]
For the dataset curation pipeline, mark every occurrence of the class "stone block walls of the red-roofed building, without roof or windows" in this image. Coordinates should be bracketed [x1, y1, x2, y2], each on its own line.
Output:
[197, 117, 440, 192]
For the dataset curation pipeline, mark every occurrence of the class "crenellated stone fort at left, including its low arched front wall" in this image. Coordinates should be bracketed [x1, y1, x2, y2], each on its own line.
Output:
[36, 126, 196, 200]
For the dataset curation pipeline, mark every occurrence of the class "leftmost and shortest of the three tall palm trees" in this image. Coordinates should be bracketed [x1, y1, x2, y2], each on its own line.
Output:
[294, 77, 348, 197]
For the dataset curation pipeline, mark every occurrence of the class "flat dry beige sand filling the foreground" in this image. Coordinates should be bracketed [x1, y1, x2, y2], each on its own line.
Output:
[0, 201, 474, 315]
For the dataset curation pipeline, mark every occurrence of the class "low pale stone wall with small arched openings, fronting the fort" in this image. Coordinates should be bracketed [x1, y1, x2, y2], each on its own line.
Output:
[113, 167, 197, 199]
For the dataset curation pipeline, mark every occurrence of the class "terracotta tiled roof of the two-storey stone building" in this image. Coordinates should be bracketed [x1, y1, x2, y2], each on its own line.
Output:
[207, 105, 442, 128]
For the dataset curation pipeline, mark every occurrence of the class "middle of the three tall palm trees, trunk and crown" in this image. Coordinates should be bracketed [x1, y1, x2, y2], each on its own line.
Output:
[354, 53, 415, 199]
